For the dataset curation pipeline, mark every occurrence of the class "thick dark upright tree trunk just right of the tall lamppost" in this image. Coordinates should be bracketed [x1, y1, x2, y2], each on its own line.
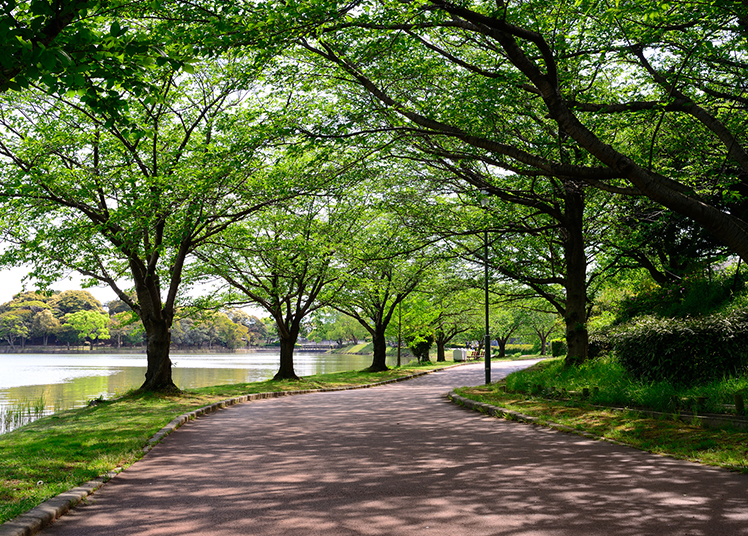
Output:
[564, 183, 589, 365]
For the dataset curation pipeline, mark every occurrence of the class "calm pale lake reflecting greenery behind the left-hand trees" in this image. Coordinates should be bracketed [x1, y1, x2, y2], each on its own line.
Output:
[0, 351, 394, 433]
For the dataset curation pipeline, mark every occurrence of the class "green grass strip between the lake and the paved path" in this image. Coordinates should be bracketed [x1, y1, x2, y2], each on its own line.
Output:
[0, 362, 452, 523]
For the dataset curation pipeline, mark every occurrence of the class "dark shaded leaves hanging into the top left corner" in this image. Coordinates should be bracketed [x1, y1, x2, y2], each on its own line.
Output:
[0, 0, 195, 122]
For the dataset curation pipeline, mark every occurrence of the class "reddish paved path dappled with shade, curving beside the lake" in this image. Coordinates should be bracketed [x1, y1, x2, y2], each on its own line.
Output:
[43, 364, 748, 536]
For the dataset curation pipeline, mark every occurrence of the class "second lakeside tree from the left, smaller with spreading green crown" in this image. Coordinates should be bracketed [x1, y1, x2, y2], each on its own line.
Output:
[197, 191, 353, 380]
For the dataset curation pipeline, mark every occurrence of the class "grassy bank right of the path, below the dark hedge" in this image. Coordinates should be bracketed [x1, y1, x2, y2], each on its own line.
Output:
[457, 359, 748, 473]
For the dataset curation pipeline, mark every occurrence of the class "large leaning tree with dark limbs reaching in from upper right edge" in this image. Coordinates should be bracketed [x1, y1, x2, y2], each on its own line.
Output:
[292, 0, 748, 259]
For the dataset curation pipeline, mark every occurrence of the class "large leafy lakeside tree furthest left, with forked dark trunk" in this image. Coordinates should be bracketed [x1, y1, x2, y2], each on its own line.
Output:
[0, 59, 303, 390]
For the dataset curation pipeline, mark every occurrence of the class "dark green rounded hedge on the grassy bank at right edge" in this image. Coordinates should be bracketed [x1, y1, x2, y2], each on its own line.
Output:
[612, 311, 748, 385]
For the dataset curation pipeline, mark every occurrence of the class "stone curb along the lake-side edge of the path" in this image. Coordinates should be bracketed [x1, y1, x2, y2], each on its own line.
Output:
[0, 363, 467, 536]
